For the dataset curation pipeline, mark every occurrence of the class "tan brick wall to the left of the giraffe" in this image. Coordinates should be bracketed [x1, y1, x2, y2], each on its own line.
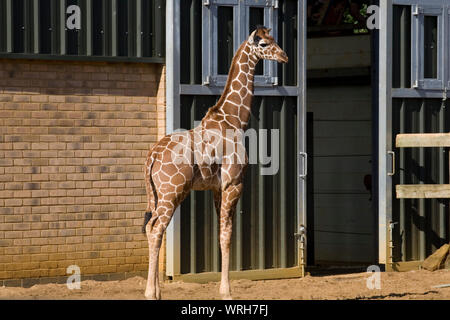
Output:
[0, 59, 165, 283]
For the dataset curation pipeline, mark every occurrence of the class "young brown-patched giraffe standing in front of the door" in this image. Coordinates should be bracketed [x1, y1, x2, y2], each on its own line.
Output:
[142, 26, 288, 300]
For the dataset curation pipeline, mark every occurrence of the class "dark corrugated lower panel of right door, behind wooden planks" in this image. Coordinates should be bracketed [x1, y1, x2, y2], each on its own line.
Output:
[392, 99, 450, 261]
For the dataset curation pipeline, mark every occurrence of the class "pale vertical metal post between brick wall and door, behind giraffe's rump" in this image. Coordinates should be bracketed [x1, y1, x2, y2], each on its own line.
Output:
[166, 0, 181, 276]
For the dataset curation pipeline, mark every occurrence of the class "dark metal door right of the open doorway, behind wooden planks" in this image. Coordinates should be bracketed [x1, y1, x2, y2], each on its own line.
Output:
[378, 0, 450, 270]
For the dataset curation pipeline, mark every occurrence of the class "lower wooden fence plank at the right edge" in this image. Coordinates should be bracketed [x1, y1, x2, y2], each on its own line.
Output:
[396, 184, 450, 199]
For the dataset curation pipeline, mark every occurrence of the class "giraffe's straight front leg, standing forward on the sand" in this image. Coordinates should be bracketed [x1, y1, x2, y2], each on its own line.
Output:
[219, 184, 242, 300]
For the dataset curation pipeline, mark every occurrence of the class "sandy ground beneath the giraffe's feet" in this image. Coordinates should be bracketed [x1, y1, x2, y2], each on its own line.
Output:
[0, 270, 450, 300]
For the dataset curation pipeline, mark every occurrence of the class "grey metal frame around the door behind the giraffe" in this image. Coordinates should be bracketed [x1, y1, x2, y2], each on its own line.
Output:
[166, 0, 307, 281]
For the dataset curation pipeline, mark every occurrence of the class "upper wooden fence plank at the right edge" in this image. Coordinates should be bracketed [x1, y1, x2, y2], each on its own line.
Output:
[395, 133, 450, 148]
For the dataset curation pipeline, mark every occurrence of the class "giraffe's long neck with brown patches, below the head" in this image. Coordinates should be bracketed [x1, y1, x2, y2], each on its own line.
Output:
[217, 41, 258, 130]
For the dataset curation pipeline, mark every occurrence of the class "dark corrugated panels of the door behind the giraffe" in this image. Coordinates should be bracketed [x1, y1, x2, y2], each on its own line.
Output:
[180, 0, 298, 274]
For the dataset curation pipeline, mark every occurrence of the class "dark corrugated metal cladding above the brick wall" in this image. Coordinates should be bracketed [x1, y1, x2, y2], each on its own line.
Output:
[0, 0, 165, 62]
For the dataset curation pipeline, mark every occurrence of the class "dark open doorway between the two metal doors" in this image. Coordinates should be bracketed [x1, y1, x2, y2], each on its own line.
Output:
[307, 0, 377, 266]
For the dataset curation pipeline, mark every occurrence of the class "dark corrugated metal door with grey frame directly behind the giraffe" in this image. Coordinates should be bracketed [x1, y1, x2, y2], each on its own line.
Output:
[166, 0, 307, 281]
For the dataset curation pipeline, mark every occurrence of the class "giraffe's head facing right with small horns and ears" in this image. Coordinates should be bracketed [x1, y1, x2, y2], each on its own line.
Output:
[247, 26, 289, 63]
